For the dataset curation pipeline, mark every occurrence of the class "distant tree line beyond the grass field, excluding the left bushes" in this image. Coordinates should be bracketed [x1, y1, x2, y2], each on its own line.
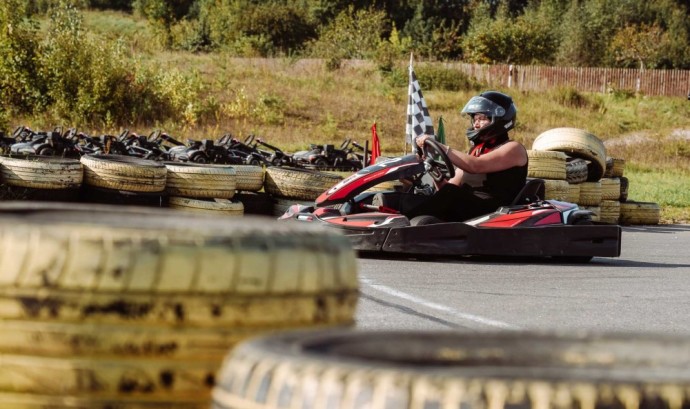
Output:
[31, 0, 690, 69]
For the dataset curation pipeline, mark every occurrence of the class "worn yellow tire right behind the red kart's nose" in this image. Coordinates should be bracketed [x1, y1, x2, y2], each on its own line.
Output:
[264, 167, 343, 201]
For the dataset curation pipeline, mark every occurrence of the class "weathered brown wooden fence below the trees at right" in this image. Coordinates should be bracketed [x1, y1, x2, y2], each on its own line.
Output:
[445, 63, 690, 97]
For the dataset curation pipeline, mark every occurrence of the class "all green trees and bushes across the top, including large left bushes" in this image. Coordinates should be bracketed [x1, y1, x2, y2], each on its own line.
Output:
[0, 0, 690, 129]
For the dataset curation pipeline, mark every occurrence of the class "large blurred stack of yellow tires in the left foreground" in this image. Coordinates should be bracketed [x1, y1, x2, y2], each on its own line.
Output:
[0, 202, 358, 409]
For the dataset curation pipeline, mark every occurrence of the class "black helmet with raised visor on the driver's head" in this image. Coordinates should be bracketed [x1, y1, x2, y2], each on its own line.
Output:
[461, 91, 517, 144]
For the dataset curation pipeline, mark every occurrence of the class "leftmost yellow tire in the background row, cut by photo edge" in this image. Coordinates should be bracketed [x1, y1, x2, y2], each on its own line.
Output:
[0, 155, 84, 190]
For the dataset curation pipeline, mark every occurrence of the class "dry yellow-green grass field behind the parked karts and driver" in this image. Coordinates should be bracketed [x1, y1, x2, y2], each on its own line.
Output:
[22, 12, 690, 223]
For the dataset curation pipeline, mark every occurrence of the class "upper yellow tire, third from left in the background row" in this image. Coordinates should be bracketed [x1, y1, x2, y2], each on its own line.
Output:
[165, 162, 237, 199]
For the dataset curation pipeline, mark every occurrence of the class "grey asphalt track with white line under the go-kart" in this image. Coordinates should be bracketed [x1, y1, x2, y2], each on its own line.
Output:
[356, 225, 690, 335]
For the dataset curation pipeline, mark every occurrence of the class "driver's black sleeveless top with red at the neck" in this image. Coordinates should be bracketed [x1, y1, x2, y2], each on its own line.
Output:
[470, 134, 528, 206]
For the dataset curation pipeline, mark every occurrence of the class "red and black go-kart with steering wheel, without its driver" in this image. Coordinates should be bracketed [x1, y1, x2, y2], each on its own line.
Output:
[280, 140, 621, 262]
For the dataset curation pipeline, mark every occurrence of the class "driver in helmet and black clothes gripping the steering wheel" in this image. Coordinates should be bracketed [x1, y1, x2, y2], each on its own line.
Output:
[405, 91, 527, 222]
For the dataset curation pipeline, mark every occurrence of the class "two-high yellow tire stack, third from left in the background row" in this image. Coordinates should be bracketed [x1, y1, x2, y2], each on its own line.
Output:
[165, 162, 244, 216]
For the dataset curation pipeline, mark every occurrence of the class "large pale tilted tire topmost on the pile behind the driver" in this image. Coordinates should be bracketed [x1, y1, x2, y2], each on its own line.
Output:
[532, 128, 606, 182]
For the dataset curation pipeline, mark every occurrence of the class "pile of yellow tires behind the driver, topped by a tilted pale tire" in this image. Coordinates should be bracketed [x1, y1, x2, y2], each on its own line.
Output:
[528, 128, 660, 224]
